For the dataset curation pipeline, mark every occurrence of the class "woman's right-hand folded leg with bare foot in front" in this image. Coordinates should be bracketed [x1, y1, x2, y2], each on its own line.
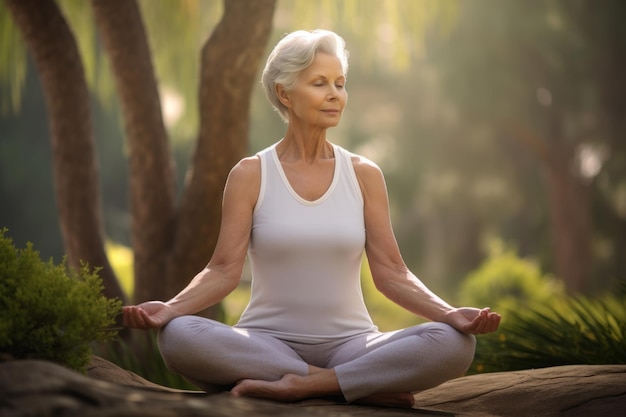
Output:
[227, 323, 475, 407]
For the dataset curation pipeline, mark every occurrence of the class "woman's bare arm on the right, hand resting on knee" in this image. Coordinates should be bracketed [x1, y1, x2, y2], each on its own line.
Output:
[353, 155, 500, 334]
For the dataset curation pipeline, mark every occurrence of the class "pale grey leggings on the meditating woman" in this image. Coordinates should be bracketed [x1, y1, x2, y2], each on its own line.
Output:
[158, 316, 475, 402]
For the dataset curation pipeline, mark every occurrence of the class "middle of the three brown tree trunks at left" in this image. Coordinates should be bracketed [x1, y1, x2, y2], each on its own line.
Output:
[91, 0, 175, 302]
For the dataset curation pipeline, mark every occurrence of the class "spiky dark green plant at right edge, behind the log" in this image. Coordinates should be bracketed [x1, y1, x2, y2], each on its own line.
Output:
[471, 295, 626, 372]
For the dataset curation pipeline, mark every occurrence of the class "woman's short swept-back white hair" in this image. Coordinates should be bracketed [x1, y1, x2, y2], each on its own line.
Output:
[261, 29, 348, 122]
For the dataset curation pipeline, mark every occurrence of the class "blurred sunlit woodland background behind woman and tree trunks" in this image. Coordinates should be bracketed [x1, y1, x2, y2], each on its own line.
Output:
[0, 0, 626, 303]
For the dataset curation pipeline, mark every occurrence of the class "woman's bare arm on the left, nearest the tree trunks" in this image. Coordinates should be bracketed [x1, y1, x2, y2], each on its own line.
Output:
[123, 157, 261, 329]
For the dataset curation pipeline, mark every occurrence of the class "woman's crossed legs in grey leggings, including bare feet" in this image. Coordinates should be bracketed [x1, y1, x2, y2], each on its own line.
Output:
[159, 316, 474, 407]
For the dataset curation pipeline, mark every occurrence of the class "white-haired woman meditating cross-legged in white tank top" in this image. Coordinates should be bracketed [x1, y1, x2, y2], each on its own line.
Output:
[124, 30, 500, 406]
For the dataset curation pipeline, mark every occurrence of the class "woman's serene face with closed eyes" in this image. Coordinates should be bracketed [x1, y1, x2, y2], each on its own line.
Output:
[279, 53, 348, 128]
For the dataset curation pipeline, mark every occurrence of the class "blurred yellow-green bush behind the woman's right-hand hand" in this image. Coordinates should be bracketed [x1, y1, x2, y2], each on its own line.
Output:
[460, 247, 564, 311]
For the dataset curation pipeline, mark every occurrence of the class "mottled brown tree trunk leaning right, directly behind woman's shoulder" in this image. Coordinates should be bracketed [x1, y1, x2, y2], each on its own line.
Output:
[167, 0, 275, 300]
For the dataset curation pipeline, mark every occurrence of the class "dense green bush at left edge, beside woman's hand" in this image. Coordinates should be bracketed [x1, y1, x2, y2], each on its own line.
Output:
[0, 229, 121, 371]
